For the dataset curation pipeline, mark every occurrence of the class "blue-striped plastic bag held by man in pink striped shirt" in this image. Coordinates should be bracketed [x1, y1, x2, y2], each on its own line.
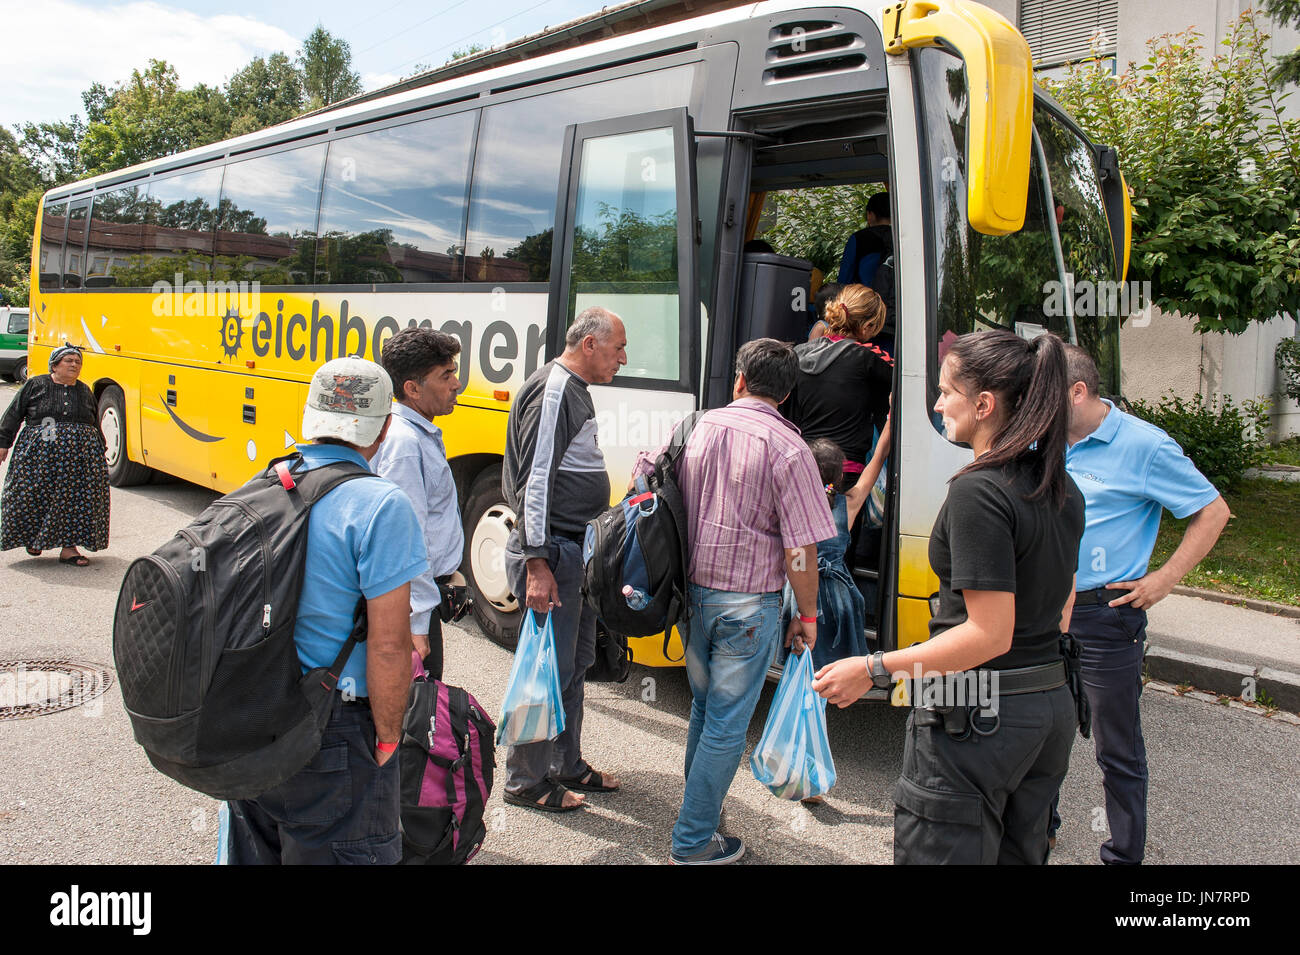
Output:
[749, 650, 835, 799]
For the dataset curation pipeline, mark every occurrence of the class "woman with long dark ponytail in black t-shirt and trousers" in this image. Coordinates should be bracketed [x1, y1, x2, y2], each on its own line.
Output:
[814, 331, 1083, 864]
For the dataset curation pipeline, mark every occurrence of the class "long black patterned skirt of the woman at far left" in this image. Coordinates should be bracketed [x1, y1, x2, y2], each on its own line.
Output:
[0, 424, 108, 551]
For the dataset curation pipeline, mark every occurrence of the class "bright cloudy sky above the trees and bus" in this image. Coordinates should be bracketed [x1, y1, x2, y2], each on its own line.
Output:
[0, 0, 614, 130]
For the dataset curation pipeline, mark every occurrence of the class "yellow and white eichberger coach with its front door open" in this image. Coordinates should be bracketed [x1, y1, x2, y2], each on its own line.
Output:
[30, 0, 1128, 691]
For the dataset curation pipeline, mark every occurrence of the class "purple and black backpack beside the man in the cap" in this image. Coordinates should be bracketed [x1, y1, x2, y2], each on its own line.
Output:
[398, 654, 497, 865]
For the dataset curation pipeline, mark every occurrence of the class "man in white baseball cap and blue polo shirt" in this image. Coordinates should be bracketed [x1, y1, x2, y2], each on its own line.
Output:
[229, 357, 429, 865]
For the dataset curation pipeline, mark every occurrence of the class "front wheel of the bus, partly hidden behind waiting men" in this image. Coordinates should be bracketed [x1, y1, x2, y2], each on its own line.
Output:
[462, 464, 523, 651]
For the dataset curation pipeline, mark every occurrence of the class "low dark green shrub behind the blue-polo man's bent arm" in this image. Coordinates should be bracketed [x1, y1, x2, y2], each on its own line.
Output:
[1132, 394, 1269, 491]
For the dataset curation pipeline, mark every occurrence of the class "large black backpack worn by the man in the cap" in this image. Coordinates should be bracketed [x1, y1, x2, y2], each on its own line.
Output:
[113, 453, 374, 799]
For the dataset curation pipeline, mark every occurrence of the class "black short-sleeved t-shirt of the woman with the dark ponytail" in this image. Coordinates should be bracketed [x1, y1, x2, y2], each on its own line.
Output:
[930, 461, 1083, 669]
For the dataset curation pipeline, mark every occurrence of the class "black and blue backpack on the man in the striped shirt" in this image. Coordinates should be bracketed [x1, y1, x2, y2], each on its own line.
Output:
[582, 411, 703, 655]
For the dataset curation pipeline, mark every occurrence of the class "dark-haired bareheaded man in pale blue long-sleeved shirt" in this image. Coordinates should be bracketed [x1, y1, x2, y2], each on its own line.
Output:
[371, 329, 464, 680]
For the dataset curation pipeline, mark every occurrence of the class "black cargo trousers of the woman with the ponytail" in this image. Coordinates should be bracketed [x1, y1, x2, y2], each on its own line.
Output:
[894, 686, 1078, 865]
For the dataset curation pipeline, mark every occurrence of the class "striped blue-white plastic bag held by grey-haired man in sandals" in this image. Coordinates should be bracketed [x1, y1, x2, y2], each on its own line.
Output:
[497, 611, 564, 746]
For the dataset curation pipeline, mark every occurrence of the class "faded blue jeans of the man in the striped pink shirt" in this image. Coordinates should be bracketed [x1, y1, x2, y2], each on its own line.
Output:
[672, 583, 781, 855]
